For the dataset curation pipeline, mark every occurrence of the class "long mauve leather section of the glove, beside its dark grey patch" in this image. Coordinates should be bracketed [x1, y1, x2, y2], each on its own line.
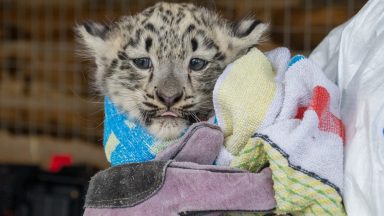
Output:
[84, 162, 276, 216]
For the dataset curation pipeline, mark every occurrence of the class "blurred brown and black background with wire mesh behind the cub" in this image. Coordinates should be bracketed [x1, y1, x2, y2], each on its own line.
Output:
[0, 0, 366, 216]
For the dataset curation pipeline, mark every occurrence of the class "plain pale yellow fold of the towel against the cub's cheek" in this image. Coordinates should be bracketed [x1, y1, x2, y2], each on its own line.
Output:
[213, 49, 276, 155]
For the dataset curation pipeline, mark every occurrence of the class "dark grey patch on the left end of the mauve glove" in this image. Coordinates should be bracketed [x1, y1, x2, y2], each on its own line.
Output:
[85, 161, 169, 208]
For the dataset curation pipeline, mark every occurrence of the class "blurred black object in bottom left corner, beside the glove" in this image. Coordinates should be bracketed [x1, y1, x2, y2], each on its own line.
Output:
[0, 165, 97, 216]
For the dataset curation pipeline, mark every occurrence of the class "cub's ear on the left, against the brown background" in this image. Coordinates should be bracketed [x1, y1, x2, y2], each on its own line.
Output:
[75, 22, 111, 55]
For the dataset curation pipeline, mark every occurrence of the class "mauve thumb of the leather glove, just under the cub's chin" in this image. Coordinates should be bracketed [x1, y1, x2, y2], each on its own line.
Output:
[155, 122, 224, 164]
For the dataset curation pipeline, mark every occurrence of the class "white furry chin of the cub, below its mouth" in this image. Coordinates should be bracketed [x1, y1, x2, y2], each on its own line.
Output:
[147, 116, 189, 140]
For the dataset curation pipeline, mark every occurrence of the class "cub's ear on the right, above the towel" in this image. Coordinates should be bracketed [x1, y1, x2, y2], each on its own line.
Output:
[230, 19, 268, 55]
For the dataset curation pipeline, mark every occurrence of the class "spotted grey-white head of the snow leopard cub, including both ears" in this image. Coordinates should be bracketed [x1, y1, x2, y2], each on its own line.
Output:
[76, 3, 267, 139]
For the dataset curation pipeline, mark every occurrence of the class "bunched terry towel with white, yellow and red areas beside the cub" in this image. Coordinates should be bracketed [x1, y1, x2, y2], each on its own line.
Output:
[213, 48, 345, 215]
